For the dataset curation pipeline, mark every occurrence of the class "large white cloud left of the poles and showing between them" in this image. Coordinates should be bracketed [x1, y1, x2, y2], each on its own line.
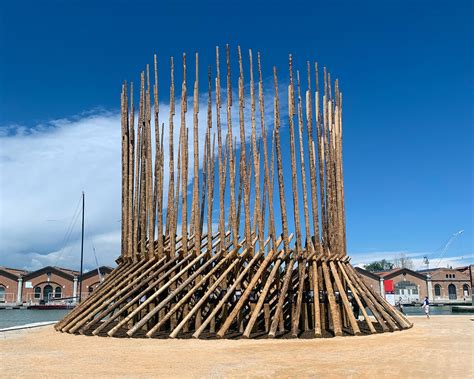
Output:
[0, 88, 276, 269]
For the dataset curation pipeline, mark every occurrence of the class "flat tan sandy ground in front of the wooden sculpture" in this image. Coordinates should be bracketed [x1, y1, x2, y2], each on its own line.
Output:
[0, 316, 474, 378]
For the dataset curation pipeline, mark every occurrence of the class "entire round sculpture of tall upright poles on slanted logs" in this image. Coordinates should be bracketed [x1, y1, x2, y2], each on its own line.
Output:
[55, 46, 412, 338]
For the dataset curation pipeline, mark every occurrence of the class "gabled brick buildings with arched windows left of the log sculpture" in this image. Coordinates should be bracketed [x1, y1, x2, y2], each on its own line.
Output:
[0, 266, 112, 304]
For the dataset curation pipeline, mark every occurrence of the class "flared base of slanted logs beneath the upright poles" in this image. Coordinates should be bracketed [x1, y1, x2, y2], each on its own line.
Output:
[55, 251, 412, 339]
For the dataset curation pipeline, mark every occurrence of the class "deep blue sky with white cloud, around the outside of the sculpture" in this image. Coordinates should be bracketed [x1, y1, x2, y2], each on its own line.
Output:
[0, 1, 474, 274]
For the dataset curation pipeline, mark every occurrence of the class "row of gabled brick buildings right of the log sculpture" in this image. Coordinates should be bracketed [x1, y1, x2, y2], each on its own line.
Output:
[356, 265, 474, 304]
